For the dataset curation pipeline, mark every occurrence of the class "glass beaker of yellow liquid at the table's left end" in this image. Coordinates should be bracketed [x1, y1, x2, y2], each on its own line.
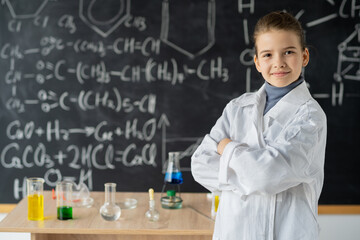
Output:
[26, 178, 45, 221]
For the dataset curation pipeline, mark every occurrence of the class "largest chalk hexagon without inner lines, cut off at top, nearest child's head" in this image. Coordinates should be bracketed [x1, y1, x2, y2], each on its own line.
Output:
[160, 0, 215, 59]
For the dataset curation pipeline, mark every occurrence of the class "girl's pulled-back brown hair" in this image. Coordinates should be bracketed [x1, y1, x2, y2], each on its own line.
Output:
[253, 11, 306, 55]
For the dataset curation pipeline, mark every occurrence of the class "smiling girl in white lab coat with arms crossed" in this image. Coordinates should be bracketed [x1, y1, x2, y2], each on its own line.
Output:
[191, 12, 326, 240]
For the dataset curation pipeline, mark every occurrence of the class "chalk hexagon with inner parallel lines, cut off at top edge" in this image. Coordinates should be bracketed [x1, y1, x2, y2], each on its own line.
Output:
[79, 0, 130, 38]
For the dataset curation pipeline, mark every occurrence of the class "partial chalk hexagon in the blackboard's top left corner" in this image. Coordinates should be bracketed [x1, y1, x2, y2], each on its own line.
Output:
[5, 0, 48, 19]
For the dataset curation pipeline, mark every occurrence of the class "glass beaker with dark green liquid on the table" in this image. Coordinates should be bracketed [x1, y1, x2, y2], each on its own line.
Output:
[56, 181, 73, 220]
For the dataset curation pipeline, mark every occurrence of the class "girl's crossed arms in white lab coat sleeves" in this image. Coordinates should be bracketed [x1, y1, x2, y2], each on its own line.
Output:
[192, 101, 326, 195]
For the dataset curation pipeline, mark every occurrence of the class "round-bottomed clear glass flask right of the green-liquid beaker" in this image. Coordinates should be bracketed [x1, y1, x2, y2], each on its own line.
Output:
[100, 183, 121, 221]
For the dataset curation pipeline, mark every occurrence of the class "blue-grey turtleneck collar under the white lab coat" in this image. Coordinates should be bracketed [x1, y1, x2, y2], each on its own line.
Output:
[264, 76, 304, 115]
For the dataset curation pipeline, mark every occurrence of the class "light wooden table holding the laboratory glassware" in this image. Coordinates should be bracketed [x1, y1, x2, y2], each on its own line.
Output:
[0, 192, 214, 240]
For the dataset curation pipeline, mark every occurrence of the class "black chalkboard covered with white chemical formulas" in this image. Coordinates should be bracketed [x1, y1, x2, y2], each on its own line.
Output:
[0, 0, 360, 204]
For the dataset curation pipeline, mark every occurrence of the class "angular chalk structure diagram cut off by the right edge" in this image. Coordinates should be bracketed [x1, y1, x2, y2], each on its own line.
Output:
[332, 24, 360, 106]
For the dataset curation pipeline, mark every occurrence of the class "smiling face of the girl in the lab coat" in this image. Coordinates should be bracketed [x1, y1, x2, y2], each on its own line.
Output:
[254, 30, 309, 87]
